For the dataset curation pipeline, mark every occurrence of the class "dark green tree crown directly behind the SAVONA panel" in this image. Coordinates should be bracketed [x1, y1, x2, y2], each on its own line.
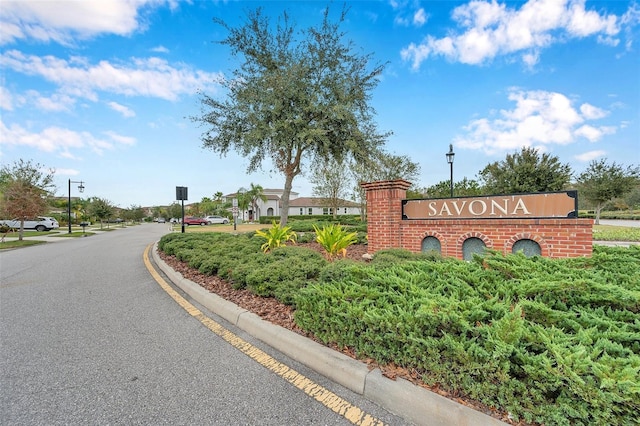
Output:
[479, 147, 572, 194]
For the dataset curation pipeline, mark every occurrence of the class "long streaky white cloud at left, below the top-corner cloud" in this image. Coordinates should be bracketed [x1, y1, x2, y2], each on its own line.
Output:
[0, 50, 221, 101]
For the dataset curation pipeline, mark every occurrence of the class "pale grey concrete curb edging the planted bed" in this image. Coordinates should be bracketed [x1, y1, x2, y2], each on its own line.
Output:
[152, 244, 506, 426]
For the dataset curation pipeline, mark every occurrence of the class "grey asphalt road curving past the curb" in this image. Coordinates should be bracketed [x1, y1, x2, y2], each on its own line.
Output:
[0, 224, 406, 425]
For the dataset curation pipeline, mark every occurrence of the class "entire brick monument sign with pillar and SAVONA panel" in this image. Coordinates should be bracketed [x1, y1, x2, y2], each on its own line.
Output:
[361, 179, 593, 259]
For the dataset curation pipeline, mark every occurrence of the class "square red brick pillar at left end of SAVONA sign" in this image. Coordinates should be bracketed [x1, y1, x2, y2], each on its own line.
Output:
[360, 179, 411, 254]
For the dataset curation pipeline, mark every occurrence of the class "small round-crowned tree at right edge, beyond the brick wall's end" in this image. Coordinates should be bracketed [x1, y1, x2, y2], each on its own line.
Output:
[576, 159, 640, 224]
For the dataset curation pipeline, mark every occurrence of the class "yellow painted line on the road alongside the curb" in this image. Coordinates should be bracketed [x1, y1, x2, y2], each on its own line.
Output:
[143, 244, 384, 426]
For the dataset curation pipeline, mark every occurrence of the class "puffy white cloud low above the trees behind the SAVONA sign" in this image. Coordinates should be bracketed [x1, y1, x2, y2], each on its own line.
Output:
[455, 89, 617, 154]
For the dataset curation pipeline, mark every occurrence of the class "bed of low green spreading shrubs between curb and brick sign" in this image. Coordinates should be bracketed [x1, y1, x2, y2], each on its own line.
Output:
[159, 230, 640, 425]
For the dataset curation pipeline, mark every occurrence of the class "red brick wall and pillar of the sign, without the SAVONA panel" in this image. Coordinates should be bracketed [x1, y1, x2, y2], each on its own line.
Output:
[362, 180, 593, 259]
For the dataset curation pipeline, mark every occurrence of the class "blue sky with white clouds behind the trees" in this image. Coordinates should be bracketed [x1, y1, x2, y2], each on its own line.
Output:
[0, 0, 640, 207]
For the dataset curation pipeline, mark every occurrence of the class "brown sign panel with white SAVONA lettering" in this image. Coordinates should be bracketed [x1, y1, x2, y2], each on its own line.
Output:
[402, 191, 578, 220]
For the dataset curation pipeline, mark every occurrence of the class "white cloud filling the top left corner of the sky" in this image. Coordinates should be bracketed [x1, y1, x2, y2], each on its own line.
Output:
[0, 0, 176, 45]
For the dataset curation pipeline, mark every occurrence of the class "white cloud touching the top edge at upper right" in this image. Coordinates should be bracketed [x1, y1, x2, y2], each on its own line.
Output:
[400, 0, 637, 70]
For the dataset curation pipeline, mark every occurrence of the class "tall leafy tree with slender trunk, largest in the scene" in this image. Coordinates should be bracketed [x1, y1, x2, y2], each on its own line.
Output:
[193, 8, 387, 225]
